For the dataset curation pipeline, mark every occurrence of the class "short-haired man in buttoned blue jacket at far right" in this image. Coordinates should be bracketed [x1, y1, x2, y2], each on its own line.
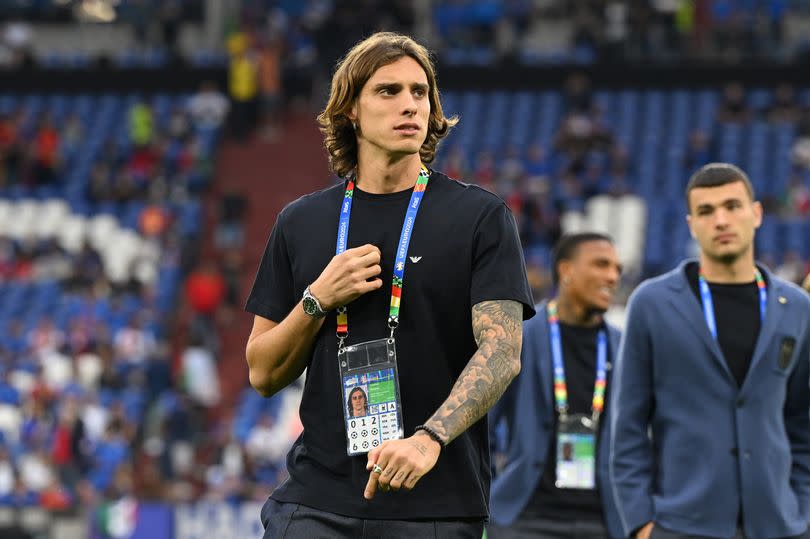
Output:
[610, 163, 810, 539]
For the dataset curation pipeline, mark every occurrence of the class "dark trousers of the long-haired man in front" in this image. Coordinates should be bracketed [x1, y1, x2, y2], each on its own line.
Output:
[261, 498, 484, 539]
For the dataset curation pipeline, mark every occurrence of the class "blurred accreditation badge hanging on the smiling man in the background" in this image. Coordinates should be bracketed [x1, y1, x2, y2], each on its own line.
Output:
[555, 414, 597, 489]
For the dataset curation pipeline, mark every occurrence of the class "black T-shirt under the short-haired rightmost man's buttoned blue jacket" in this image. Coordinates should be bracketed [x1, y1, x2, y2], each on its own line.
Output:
[686, 262, 767, 387]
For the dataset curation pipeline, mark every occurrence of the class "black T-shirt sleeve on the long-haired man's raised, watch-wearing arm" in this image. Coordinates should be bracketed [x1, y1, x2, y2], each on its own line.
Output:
[245, 211, 297, 322]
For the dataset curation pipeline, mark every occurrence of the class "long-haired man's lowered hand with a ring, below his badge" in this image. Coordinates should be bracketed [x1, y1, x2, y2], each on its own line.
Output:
[363, 431, 441, 500]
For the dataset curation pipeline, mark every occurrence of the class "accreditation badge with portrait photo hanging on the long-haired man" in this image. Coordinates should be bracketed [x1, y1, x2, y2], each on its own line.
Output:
[338, 338, 403, 456]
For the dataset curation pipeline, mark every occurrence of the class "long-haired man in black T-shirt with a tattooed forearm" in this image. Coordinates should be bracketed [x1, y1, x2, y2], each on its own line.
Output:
[241, 33, 534, 539]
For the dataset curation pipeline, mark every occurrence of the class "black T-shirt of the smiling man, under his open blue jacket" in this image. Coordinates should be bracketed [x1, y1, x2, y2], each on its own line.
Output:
[526, 322, 610, 519]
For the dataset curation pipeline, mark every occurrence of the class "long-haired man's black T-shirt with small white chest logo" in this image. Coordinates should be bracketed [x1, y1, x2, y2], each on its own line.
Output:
[246, 172, 534, 519]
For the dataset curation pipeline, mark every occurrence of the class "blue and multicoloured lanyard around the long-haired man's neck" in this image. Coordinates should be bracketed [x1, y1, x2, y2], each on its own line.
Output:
[335, 166, 430, 349]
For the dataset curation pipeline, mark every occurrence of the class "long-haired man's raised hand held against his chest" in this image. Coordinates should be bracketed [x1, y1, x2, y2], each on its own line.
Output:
[309, 244, 382, 311]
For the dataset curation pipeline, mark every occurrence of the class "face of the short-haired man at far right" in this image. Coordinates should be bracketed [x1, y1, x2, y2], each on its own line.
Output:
[686, 181, 762, 263]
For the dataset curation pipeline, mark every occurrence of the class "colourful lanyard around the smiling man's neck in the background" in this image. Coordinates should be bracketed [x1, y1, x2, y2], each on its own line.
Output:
[547, 301, 607, 424]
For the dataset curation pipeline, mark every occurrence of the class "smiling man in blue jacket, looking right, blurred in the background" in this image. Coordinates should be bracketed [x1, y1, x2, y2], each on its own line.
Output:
[488, 233, 622, 539]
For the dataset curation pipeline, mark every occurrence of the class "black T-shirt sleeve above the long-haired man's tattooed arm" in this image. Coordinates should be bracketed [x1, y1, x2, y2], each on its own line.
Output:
[470, 204, 534, 320]
